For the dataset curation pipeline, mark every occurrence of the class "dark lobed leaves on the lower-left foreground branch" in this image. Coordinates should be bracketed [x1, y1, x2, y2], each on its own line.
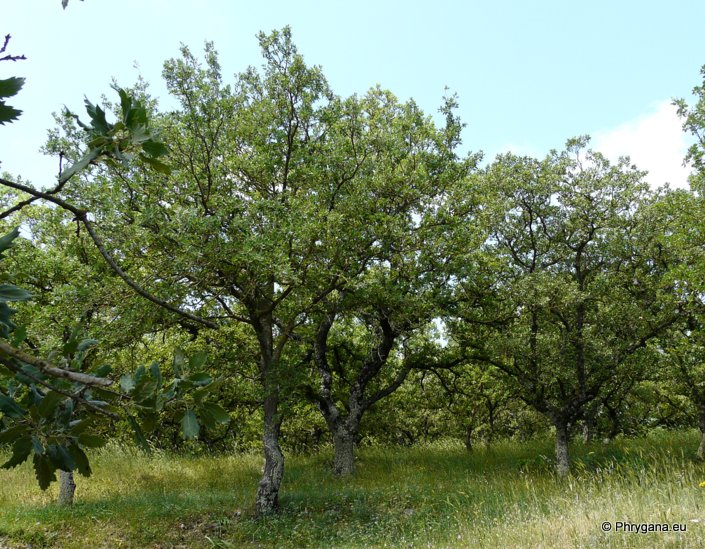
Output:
[0, 312, 230, 489]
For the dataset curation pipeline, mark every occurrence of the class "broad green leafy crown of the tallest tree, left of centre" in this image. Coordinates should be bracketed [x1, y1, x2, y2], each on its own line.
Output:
[33, 29, 482, 504]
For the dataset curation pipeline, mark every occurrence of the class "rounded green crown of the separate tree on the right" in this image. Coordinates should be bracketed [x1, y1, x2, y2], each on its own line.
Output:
[448, 138, 680, 450]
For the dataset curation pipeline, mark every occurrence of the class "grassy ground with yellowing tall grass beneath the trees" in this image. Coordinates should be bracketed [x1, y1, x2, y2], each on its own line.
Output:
[0, 432, 705, 549]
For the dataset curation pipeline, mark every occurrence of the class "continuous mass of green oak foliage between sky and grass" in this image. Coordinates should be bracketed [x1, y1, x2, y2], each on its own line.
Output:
[0, 16, 705, 512]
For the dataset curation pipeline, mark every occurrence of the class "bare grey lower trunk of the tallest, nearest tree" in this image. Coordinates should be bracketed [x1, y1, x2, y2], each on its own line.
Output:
[255, 395, 284, 515]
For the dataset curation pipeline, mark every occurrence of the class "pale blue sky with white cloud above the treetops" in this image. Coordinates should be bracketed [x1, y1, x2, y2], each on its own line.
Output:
[0, 0, 705, 186]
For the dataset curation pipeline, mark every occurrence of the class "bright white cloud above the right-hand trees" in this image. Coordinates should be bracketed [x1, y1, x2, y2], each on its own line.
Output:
[590, 101, 690, 188]
